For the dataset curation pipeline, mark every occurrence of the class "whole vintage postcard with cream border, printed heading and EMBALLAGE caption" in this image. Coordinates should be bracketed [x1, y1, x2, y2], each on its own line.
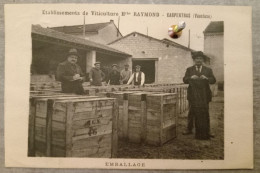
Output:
[5, 4, 253, 169]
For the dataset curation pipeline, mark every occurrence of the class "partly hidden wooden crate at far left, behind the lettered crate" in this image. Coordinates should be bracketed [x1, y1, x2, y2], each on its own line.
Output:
[28, 94, 97, 156]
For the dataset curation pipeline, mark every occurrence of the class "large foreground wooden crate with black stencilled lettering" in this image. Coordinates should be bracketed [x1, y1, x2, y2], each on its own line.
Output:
[51, 98, 118, 158]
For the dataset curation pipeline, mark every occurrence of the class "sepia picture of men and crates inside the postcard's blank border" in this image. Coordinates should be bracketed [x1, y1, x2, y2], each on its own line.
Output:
[28, 18, 224, 159]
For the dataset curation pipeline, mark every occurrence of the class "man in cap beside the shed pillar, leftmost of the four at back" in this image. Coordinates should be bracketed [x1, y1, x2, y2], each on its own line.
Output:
[89, 61, 105, 86]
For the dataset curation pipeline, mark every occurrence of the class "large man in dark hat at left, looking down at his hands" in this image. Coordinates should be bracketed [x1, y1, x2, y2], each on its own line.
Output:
[56, 48, 85, 94]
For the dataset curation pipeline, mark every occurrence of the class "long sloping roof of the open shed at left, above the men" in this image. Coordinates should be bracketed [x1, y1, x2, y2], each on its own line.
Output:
[32, 25, 131, 56]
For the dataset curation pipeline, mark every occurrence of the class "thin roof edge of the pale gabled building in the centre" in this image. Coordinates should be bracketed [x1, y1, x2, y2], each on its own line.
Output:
[108, 32, 192, 51]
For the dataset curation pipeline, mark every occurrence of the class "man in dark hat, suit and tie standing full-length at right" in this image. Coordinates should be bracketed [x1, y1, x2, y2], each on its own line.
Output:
[183, 51, 216, 140]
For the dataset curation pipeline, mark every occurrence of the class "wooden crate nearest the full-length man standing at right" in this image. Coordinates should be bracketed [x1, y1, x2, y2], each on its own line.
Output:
[146, 93, 178, 145]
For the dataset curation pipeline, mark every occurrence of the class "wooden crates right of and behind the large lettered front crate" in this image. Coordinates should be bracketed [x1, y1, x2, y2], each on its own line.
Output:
[97, 91, 178, 146]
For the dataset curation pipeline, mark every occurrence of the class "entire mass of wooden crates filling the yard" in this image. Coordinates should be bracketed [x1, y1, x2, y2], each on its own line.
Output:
[28, 84, 195, 158]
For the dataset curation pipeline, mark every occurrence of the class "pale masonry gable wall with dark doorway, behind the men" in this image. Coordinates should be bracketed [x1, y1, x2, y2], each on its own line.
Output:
[109, 32, 193, 83]
